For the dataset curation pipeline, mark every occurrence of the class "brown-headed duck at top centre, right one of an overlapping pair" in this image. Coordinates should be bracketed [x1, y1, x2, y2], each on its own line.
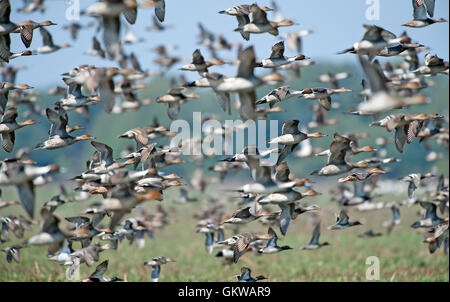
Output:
[234, 4, 294, 36]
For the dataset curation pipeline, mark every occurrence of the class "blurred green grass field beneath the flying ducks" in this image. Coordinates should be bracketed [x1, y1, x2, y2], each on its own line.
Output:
[0, 185, 449, 281]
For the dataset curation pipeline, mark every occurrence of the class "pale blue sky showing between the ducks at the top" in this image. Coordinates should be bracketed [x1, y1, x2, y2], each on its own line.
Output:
[7, 0, 449, 89]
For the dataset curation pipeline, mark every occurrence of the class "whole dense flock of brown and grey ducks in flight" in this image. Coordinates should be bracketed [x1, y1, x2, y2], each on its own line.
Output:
[0, 0, 449, 282]
